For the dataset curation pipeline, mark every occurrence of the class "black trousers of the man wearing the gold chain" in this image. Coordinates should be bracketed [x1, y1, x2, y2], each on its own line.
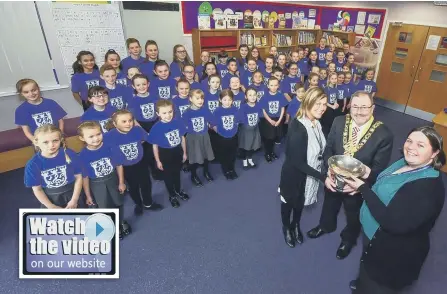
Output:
[320, 188, 363, 245]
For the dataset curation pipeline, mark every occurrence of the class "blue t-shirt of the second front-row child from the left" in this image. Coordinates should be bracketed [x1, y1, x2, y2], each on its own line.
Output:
[79, 144, 122, 179]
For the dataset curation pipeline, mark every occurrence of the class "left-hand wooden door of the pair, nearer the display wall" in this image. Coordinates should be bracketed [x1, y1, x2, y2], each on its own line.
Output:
[376, 24, 429, 105]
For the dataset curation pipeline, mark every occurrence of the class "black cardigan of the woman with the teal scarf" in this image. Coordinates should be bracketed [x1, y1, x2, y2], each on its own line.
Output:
[359, 175, 445, 290]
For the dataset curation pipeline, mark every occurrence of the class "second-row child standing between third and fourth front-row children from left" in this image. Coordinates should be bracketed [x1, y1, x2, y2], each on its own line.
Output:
[127, 73, 162, 181]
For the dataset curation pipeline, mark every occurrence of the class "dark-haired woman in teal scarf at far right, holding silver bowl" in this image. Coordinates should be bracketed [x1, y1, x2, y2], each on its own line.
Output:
[346, 127, 446, 294]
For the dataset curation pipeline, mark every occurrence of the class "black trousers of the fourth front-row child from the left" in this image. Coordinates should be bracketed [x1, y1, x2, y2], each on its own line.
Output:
[158, 145, 183, 196]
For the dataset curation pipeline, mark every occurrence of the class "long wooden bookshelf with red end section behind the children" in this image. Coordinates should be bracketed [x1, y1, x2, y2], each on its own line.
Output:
[192, 28, 355, 64]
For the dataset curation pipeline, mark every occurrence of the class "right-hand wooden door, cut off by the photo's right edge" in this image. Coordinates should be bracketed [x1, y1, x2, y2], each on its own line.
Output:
[407, 27, 447, 114]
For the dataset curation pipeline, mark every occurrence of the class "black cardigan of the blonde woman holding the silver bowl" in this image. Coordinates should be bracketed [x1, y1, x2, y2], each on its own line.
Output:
[279, 119, 326, 203]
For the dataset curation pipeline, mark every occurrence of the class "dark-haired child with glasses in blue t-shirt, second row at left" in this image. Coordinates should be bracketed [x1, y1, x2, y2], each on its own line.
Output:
[81, 86, 116, 133]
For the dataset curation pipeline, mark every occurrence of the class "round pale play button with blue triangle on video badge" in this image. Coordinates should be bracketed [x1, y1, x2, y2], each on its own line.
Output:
[84, 213, 116, 241]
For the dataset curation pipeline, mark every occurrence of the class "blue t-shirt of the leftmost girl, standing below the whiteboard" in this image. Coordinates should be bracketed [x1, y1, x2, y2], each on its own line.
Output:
[15, 98, 67, 134]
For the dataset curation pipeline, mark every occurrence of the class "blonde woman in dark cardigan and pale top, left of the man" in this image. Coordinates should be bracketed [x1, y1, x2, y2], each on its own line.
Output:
[279, 88, 327, 248]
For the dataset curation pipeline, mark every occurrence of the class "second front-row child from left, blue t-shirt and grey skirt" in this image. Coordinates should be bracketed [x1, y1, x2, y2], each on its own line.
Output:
[78, 121, 132, 239]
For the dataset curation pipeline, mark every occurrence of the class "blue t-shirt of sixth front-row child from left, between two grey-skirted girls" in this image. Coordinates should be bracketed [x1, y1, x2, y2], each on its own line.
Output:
[212, 106, 238, 138]
